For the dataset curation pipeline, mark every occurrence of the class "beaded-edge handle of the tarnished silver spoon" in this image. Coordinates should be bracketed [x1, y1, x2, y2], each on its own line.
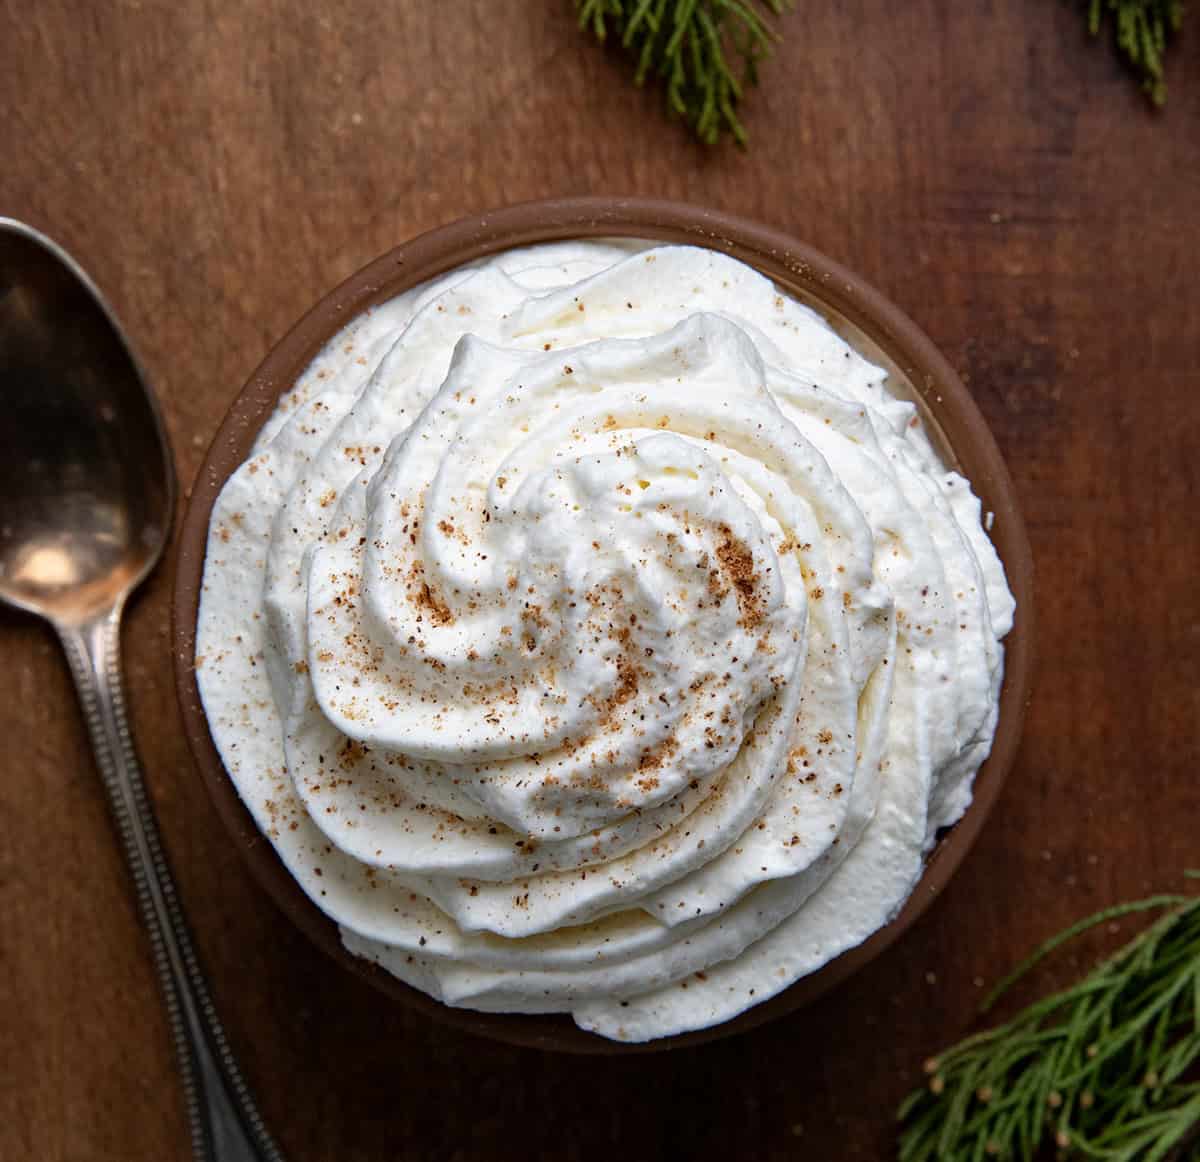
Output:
[55, 604, 283, 1162]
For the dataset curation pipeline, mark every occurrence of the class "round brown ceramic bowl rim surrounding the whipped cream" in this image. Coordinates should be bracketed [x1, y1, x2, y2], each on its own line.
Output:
[173, 198, 1033, 1053]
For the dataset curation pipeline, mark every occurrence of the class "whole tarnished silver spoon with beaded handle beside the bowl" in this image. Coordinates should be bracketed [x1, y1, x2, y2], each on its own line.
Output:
[0, 218, 282, 1162]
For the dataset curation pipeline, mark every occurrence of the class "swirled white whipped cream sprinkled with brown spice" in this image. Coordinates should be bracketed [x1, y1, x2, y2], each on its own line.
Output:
[196, 241, 1014, 1041]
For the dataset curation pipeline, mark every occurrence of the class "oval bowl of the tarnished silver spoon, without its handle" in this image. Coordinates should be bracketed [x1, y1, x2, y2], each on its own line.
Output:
[0, 218, 175, 624]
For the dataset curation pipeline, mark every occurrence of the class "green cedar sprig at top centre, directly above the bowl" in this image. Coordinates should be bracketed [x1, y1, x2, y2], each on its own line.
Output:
[575, 0, 792, 145]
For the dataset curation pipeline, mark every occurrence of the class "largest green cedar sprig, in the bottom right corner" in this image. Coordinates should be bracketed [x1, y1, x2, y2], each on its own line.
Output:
[899, 873, 1200, 1162]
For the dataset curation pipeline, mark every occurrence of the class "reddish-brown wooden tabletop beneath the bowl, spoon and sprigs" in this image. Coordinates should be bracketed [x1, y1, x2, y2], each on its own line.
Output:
[0, 0, 1200, 1162]
